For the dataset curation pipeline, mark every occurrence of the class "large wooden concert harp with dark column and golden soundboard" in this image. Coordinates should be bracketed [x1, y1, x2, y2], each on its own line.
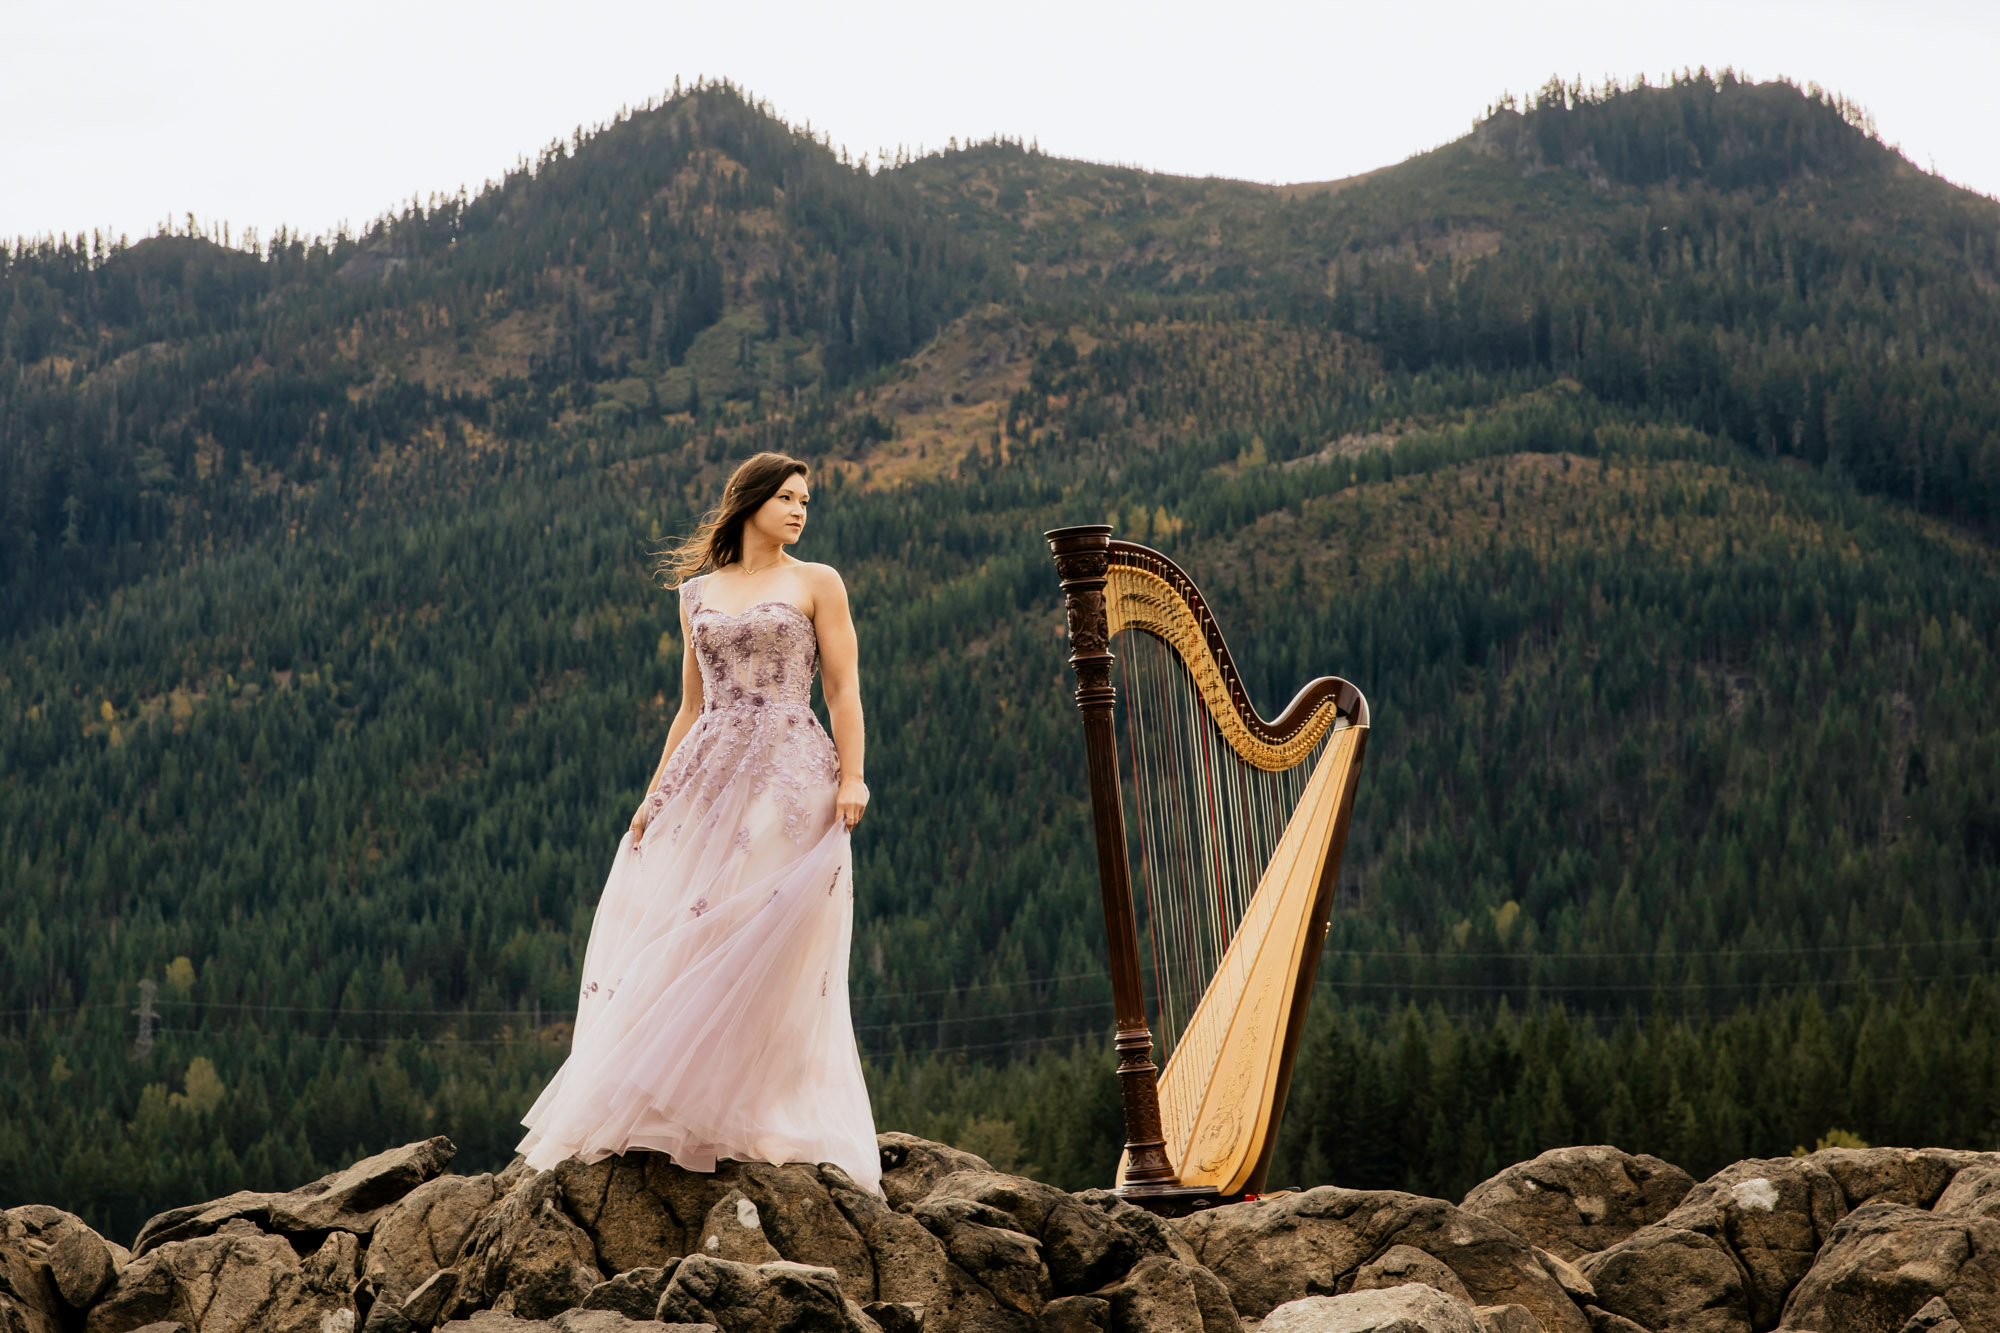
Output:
[1046, 524, 1368, 1213]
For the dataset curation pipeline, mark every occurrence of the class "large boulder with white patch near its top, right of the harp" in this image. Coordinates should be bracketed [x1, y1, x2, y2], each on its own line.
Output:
[1580, 1157, 1846, 1329]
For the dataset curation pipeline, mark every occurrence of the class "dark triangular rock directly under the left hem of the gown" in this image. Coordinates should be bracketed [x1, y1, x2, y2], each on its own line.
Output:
[448, 1171, 604, 1319]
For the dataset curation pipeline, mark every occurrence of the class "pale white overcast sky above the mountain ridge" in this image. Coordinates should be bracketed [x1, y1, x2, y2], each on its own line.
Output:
[0, 0, 2000, 240]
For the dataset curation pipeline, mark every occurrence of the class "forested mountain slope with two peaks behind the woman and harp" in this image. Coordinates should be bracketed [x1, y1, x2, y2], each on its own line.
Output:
[0, 78, 2000, 1231]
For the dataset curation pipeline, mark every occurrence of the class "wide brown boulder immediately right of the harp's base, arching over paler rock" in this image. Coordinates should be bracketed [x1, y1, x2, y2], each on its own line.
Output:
[1172, 1185, 1588, 1333]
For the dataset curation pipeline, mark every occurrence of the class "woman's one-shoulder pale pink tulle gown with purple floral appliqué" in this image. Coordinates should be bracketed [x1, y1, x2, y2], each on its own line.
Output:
[520, 578, 882, 1193]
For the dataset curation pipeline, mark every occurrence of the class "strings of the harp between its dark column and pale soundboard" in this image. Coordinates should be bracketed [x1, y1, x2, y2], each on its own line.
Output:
[1118, 630, 1332, 1125]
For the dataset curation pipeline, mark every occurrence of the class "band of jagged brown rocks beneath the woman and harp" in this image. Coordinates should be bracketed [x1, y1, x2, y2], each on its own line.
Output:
[31, 1135, 2000, 1333]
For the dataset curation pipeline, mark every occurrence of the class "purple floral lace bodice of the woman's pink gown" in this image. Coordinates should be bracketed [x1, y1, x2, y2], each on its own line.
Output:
[650, 576, 840, 851]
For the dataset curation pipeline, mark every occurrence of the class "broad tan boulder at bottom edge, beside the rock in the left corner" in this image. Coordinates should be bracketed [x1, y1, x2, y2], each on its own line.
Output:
[84, 1219, 360, 1333]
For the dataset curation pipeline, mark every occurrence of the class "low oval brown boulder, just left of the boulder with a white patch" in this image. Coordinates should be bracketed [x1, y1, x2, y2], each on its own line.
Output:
[1458, 1145, 1694, 1261]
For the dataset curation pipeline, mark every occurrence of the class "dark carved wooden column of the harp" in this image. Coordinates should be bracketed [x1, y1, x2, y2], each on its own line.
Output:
[1044, 522, 1180, 1193]
